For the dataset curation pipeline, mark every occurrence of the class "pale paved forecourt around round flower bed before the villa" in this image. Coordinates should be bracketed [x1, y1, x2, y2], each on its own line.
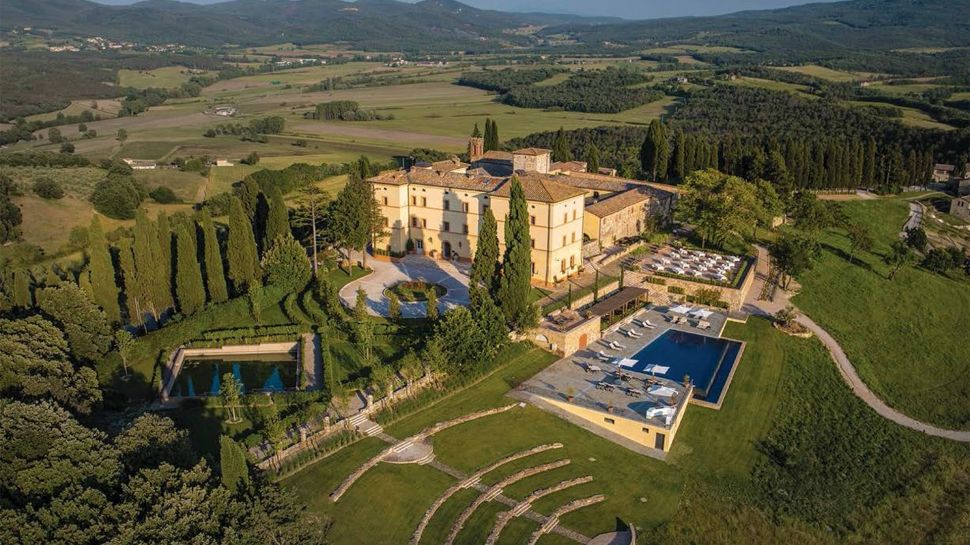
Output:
[340, 255, 469, 318]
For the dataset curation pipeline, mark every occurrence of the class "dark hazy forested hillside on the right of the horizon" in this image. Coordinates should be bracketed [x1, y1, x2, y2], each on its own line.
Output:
[542, 0, 970, 70]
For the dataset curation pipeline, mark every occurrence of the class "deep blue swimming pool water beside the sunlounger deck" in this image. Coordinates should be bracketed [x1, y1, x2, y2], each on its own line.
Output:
[630, 329, 742, 403]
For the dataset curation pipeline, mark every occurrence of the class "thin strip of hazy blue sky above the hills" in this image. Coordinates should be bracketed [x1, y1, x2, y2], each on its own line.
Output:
[95, 0, 831, 19]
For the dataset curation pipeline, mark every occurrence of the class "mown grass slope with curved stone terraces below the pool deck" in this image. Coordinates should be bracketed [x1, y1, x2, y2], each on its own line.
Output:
[283, 318, 970, 545]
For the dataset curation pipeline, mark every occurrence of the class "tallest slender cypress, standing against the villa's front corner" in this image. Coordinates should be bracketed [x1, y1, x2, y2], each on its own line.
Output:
[498, 180, 536, 330]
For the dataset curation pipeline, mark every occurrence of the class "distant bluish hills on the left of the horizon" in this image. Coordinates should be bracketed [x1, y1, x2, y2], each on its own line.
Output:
[0, 0, 615, 51]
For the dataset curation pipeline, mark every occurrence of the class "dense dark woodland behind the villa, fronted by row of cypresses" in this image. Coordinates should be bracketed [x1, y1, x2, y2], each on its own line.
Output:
[505, 85, 970, 192]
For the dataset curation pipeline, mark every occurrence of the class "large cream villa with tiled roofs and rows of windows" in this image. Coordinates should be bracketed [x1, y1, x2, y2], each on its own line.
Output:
[369, 138, 676, 285]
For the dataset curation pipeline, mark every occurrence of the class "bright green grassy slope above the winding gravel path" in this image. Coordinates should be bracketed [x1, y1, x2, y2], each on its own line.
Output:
[794, 198, 970, 429]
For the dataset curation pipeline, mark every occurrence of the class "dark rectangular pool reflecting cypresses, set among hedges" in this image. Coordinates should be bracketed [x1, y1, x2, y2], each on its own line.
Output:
[169, 354, 297, 397]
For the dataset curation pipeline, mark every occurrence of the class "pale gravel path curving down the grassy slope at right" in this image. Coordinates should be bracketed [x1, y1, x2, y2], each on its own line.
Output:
[744, 246, 970, 443]
